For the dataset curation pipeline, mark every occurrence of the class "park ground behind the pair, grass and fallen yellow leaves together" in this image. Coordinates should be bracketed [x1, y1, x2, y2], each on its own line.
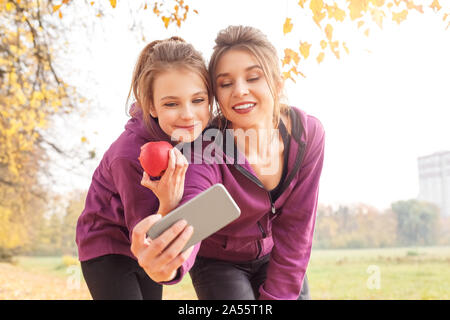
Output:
[0, 247, 450, 300]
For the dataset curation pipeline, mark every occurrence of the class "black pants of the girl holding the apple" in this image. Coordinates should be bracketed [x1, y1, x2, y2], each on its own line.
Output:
[81, 254, 162, 300]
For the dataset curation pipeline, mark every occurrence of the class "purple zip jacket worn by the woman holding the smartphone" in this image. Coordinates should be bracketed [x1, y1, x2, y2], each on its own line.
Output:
[174, 108, 325, 299]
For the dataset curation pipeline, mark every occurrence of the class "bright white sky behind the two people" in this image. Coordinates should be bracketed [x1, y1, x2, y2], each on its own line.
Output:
[51, 0, 450, 209]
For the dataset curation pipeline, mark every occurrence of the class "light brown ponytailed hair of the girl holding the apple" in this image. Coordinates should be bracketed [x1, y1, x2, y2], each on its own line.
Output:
[127, 37, 213, 133]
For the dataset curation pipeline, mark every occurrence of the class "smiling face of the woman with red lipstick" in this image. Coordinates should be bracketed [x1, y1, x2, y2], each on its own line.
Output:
[213, 49, 274, 129]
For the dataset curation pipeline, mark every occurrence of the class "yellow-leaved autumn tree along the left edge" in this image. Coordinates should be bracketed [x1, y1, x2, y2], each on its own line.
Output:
[0, 0, 77, 258]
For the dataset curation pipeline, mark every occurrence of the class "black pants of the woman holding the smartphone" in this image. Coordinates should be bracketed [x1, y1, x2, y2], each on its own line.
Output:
[190, 255, 311, 300]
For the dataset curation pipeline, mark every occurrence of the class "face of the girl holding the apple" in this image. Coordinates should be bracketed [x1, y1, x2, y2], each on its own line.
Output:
[150, 69, 210, 142]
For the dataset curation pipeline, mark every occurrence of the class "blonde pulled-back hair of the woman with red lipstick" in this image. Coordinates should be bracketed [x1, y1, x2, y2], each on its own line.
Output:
[208, 26, 289, 129]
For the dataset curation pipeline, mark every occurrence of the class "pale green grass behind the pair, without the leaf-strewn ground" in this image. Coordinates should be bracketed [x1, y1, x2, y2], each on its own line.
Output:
[11, 247, 450, 300]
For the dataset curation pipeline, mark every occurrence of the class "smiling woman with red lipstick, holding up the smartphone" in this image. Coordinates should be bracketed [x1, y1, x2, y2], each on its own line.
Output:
[132, 26, 324, 300]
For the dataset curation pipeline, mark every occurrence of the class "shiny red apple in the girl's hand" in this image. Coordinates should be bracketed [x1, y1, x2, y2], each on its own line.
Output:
[138, 141, 173, 177]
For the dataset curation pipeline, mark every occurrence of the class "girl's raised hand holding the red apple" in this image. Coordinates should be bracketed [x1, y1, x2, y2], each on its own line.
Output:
[141, 148, 189, 215]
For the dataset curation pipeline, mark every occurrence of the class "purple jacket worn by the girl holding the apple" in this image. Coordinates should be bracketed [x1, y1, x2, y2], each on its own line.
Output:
[76, 106, 170, 261]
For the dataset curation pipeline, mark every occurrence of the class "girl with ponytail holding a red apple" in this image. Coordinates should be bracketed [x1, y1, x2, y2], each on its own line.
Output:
[76, 37, 212, 299]
